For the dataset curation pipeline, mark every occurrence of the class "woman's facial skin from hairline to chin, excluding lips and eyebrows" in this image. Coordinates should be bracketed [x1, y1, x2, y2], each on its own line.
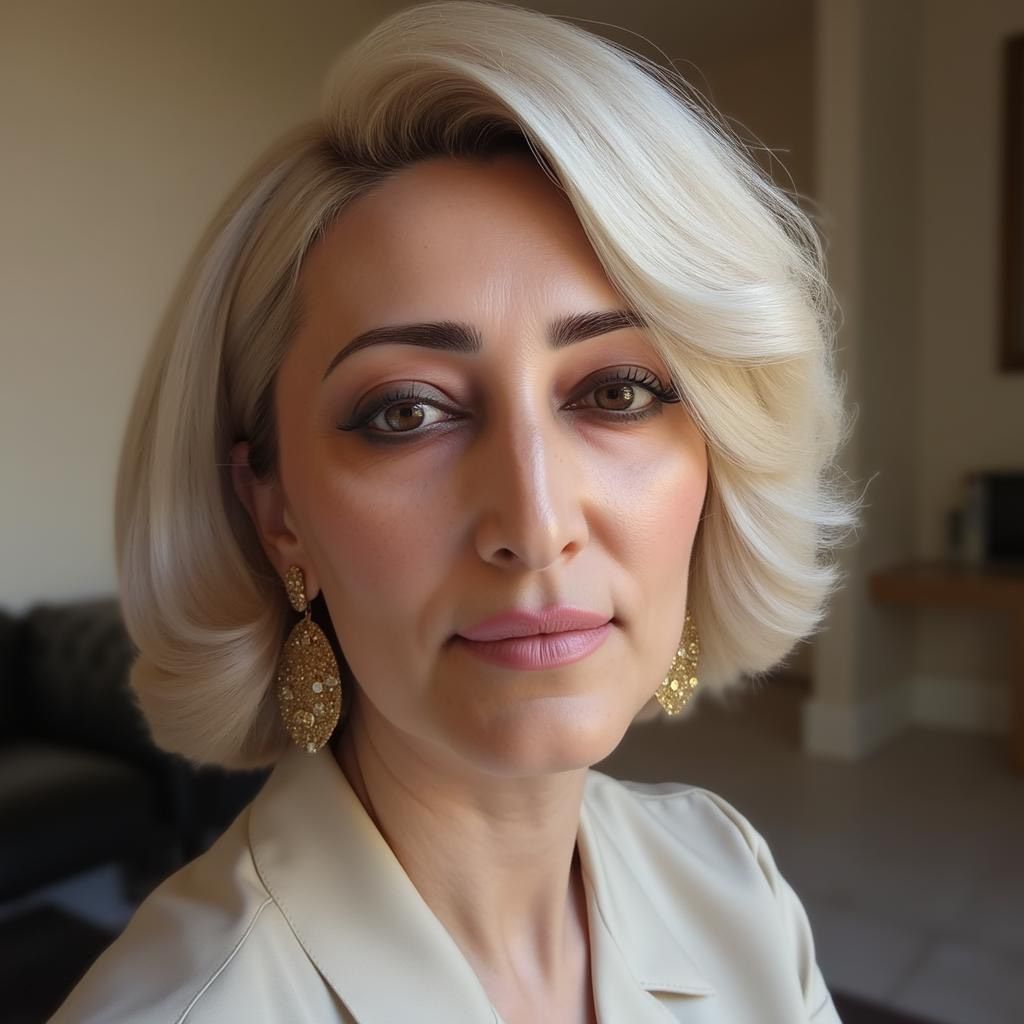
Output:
[260, 149, 707, 775]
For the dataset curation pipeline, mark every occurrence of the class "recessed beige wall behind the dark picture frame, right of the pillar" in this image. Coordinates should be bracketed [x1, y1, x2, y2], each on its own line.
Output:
[914, 0, 1024, 702]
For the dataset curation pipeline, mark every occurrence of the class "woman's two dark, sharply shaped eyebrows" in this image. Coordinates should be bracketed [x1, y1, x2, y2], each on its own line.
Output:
[322, 309, 647, 383]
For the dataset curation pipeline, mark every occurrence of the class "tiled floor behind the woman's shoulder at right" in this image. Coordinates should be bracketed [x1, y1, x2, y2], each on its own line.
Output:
[597, 680, 1024, 1024]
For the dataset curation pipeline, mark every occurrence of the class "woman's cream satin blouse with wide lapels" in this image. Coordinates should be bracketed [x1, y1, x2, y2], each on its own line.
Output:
[51, 748, 839, 1024]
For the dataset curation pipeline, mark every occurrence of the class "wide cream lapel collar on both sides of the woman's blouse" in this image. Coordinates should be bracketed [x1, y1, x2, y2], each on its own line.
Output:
[249, 748, 714, 1024]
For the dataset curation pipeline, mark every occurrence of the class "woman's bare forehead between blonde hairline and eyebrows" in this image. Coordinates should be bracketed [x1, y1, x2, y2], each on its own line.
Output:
[294, 155, 614, 321]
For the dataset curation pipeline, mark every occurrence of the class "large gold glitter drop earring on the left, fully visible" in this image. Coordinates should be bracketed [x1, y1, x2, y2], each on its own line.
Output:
[274, 565, 341, 754]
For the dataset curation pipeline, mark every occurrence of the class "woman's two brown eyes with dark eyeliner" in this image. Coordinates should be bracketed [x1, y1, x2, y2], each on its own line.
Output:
[338, 367, 680, 443]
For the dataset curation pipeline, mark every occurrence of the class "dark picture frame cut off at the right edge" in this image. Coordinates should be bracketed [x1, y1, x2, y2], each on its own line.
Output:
[999, 33, 1024, 373]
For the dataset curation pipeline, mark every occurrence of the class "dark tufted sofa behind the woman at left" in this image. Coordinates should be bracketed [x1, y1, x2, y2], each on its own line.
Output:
[0, 597, 266, 901]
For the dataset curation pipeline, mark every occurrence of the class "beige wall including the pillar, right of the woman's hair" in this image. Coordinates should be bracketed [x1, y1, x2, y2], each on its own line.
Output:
[805, 0, 1024, 757]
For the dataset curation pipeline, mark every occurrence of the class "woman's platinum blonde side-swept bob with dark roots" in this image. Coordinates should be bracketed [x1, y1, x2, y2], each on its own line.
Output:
[115, 0, 857, 768]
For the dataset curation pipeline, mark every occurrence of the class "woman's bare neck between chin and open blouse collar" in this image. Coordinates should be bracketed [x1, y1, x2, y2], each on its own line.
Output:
[335, 706, 589, 1008]
